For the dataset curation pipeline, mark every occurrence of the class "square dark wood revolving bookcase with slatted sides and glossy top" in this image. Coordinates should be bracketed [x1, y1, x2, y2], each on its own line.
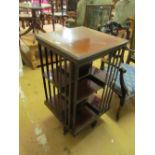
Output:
[36, 27, 128, 135]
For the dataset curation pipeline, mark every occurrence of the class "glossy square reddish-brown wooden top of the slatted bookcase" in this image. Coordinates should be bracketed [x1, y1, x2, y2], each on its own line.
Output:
[36, 26, 128, 60]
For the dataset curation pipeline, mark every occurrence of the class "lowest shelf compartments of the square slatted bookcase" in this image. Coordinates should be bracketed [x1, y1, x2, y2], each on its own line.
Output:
[45, 94, 106, 135]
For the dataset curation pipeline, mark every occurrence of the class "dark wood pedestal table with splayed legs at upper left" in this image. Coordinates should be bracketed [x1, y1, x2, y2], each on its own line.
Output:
[19, 3, 51, 36]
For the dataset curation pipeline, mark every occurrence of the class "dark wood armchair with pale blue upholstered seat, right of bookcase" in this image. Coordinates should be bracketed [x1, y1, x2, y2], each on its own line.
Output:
[114, 49, 135, 120]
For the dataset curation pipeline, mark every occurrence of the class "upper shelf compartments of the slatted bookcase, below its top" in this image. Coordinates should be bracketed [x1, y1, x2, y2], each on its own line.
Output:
[43, 64, 106, 87]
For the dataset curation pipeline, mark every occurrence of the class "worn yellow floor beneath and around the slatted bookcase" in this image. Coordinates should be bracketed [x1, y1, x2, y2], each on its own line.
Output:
[19, 57, 135, 155]
